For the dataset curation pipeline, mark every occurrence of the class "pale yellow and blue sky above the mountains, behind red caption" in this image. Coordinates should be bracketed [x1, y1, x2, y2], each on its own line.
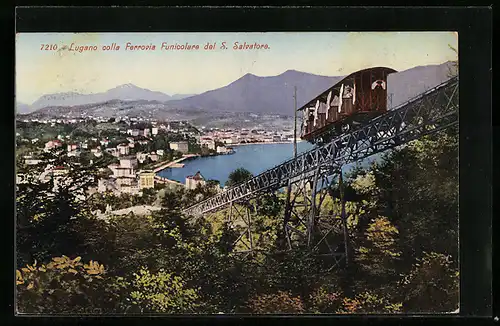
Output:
[16, 32, 458, 104]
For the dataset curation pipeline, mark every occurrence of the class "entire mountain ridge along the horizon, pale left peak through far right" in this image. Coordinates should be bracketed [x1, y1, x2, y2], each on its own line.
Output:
[16, 62, 451, 116]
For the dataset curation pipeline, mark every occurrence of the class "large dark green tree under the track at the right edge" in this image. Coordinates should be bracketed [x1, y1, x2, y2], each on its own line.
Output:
[372, 130, 458, 268]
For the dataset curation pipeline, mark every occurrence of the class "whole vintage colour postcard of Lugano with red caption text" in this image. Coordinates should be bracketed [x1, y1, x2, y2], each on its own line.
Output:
[15, 31, 460, 315]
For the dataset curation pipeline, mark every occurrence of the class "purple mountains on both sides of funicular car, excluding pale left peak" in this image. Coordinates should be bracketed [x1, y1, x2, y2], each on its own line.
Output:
[167, 62, 451, 115]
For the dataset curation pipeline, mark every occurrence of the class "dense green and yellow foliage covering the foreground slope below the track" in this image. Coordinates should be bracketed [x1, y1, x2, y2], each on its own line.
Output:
[16, 130, 459, 314]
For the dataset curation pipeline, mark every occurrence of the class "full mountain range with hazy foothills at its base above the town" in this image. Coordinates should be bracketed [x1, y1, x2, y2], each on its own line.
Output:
[17, 62, 458, 119]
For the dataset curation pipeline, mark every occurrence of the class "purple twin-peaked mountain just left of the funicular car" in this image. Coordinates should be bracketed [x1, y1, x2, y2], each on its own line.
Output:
[168, 70, 341, 115]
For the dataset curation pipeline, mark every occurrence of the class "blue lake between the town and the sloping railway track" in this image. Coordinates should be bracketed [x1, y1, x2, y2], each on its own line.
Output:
[157, 141, 380, 186]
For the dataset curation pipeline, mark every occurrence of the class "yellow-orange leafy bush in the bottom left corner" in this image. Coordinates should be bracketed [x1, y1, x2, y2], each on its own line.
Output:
[16, 255, 128, 314]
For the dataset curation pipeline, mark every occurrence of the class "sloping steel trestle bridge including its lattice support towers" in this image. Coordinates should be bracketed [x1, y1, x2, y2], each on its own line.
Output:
[184, 76, 459, 264]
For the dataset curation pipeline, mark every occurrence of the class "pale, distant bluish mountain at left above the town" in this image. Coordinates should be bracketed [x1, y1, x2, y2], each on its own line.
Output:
[31, 84, 176, 110]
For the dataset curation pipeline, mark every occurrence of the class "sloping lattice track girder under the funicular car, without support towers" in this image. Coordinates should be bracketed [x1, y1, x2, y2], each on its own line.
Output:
[184, 76, 459, 216]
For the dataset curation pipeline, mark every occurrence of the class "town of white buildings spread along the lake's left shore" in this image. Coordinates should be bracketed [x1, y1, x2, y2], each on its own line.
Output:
[16, 117, 293, 201]
